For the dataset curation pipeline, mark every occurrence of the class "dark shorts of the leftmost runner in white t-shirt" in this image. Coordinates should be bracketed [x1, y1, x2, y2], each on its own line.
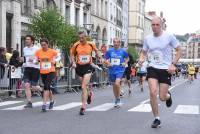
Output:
[23, 67, 40, 86]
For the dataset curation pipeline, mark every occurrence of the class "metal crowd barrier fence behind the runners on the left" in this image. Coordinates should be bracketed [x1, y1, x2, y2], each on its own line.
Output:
[0, 66, 108, 99]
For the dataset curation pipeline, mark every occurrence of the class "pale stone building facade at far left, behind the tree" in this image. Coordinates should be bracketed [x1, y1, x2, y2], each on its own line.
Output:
[0, 0, 91, 51]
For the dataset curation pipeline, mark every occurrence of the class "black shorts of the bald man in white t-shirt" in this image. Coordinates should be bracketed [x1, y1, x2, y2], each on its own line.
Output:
[147, 67, 171, 85]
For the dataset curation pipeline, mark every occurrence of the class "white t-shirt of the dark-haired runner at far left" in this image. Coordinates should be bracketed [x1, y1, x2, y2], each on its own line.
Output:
[23, 46, 40, 69]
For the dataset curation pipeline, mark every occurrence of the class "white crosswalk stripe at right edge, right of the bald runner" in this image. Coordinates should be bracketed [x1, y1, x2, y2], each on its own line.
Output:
[174, 105, 199, 114]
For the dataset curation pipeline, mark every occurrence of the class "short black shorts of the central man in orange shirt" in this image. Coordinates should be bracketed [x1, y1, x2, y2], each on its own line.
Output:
[76, 64, 93, 77]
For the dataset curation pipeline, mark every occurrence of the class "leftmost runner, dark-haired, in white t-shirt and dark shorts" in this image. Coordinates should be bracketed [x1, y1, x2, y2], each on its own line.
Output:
[23, 35, 40, 108]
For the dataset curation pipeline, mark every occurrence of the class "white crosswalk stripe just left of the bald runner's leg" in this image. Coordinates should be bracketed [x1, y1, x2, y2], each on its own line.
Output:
[128, 104, 152, 112]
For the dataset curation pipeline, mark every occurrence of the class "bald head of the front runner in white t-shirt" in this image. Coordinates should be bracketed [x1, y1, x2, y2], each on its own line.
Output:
[151, 16, 162, 36]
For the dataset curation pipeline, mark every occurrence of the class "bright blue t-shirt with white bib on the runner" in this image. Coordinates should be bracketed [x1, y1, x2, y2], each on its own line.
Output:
[105, 48, 128, 73]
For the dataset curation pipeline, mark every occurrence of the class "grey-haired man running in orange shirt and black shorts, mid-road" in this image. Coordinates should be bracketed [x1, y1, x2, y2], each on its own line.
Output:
[70, 31, 100, 115]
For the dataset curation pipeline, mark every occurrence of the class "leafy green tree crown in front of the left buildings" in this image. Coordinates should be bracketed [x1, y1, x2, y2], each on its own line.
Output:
[29, 8, 78, 52]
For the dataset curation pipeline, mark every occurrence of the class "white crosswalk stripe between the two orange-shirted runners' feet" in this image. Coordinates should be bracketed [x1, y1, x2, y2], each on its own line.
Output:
[53, 102, 82, 110]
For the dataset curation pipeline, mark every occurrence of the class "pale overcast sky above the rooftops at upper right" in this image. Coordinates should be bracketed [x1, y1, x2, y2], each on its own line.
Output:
[145, 0, 200, 35]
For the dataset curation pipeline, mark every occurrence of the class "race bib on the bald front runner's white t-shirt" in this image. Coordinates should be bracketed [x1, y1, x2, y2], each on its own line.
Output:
[149, 52, 163, 64]
